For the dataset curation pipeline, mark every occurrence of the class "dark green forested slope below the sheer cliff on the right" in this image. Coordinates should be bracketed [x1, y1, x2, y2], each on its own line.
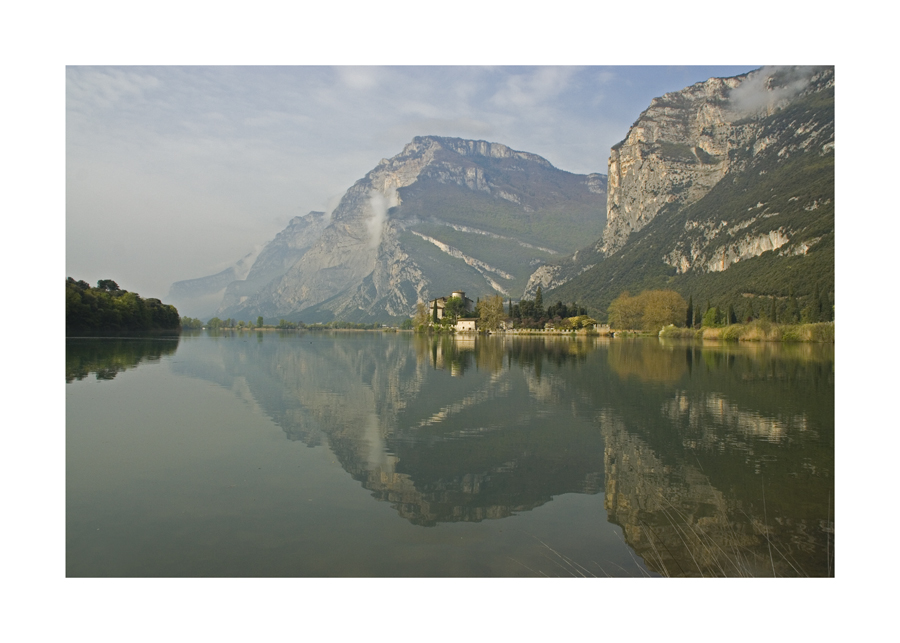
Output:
[545, 68, 835, 322]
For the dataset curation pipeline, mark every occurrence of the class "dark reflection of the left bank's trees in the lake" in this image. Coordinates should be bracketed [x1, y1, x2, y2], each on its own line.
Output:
[66, 335, 179, 382]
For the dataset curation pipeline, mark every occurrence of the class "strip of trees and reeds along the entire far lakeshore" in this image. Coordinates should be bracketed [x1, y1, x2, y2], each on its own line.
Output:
[66, 277, 835, 342]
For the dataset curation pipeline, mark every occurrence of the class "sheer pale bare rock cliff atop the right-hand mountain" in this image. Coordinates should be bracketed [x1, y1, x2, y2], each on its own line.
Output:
[598, 68, 834, 255]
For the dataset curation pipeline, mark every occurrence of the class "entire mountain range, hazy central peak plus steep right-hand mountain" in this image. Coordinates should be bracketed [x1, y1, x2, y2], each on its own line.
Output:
[169, 67, 834, 323]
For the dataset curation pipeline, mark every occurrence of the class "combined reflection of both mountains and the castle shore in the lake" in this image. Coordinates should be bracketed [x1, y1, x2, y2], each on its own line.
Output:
[167, 333, 834, 576]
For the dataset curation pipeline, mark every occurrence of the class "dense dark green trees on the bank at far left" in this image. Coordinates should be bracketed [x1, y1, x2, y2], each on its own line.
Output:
[66, 277, 181, 335]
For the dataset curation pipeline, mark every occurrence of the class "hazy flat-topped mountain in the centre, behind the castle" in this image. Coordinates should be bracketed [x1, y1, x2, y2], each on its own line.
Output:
[172, 136, 606, 322]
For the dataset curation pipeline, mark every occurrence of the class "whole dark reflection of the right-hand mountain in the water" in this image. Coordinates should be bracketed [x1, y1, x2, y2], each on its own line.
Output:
[601, 342, 834, 576]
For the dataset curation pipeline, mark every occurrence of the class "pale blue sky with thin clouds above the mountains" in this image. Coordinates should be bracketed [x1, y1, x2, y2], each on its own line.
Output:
[65, 65, 762, 301]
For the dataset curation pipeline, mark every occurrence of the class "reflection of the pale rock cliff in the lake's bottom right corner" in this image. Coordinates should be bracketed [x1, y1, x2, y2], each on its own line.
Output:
[603, 419, 834, 576]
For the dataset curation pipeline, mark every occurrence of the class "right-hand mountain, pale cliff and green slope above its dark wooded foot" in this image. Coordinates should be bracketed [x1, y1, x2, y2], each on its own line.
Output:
[526, 67, 834, 310]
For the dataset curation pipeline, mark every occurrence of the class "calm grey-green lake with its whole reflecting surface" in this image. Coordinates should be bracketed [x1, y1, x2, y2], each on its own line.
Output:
[66, 331, 835, 577]
